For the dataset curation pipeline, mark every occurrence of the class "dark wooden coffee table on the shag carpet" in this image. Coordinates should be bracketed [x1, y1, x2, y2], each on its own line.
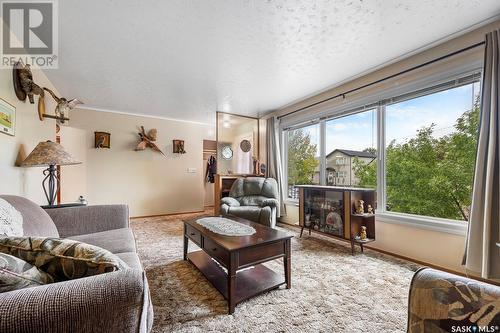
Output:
[184, 216, 292, 314]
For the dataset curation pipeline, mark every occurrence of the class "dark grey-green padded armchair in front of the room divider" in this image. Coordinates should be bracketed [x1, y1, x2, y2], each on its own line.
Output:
[220, 177, 279, 228]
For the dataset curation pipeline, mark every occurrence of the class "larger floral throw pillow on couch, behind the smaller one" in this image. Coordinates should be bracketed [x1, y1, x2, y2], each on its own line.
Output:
[0, 236, 128, 282]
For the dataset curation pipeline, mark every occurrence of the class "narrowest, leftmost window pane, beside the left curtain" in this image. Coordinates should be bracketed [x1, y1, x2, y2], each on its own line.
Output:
[287, 124, 320, 199]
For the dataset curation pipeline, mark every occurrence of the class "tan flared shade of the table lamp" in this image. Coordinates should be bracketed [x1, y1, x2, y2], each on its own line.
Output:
[21, 141, 82, 167]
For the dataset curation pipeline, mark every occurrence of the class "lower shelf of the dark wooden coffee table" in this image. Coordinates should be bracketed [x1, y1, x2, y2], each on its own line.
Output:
[187, 250, 285, 304]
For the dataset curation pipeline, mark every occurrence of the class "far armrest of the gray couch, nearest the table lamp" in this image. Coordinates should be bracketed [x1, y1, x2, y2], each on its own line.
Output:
[45, 205, 129, 237]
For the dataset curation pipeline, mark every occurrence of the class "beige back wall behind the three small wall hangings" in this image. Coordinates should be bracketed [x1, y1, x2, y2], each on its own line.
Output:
[68, 110, 213, 216]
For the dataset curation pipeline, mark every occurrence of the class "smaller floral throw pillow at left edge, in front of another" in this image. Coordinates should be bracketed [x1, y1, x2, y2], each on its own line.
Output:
[0, 253, 54, 293]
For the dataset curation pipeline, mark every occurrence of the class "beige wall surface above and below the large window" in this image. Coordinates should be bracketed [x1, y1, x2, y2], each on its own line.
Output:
[268, 21, 500, 272]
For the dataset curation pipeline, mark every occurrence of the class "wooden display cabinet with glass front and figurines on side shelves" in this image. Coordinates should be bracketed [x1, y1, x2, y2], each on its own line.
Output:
[296, 185, 376, 254]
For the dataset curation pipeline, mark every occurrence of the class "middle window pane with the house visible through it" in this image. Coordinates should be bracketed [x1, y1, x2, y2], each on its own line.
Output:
[325, 109, 377, 188]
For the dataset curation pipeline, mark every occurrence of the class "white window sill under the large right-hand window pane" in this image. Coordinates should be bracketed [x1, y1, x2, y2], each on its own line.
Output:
[376, 212, 467, 236]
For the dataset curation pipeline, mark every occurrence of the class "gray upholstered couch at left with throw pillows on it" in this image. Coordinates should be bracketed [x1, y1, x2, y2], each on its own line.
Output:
[0, 195, 153, 332]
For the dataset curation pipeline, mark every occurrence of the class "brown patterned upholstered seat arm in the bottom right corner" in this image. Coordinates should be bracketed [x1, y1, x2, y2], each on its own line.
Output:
[407, 268, 500, 333]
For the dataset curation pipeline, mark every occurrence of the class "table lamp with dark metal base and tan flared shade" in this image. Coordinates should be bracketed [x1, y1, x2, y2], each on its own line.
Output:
[21, 141, 82, 206]
